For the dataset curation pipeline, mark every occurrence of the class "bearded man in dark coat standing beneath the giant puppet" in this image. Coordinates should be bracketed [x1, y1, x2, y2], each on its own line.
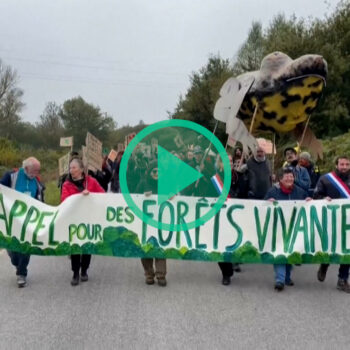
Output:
[247, 147, 272, 199]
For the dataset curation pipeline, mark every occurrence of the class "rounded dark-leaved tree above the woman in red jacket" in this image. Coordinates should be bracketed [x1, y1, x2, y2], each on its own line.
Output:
[59, 96, 116, 148]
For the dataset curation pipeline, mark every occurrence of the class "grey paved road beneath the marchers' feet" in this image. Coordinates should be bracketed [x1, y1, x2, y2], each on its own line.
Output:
[0, 252, 350, 350]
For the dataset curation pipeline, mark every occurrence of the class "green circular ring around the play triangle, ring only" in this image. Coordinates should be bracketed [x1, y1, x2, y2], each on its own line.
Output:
[119, 119, 231, 231]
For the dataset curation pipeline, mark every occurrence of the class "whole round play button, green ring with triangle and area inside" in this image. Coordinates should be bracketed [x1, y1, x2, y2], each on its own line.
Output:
[119, 119, 231, 232]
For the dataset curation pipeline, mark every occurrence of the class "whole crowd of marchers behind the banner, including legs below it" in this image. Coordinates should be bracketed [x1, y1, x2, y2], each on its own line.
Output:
[0, 145, 350, 293]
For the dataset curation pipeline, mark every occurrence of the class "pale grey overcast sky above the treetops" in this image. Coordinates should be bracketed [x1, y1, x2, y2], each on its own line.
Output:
[0, 0, 338, 126]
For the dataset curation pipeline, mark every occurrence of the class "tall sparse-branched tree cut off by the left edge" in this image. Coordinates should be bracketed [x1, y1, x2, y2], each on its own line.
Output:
[0, 59, 24, 139]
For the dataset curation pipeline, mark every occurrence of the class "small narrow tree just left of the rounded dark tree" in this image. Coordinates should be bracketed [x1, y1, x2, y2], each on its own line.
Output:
[36, 102, 64, 149]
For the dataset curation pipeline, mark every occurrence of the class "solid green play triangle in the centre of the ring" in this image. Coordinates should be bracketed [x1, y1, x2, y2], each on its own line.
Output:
[158, 146, 203, 205]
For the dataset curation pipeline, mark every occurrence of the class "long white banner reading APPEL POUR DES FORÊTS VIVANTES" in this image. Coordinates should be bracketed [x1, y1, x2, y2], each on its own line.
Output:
[0, 186, 350, 264]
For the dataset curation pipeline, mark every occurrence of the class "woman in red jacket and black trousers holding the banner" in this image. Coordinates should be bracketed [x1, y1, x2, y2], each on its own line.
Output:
[61, 158, 105, 286]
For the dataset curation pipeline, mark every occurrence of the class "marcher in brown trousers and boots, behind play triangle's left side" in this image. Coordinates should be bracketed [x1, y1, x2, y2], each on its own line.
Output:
[137, 160, 167, 287]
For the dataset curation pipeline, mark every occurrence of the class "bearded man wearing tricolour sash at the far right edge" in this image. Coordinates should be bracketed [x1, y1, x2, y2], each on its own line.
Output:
[314, 155, 350, 293]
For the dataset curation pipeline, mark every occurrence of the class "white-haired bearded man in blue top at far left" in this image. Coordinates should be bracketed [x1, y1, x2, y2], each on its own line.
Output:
[0, 157, 45, 288]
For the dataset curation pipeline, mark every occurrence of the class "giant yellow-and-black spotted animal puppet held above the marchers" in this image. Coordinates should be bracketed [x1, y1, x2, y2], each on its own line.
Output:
[214, 52, 327, 157]
